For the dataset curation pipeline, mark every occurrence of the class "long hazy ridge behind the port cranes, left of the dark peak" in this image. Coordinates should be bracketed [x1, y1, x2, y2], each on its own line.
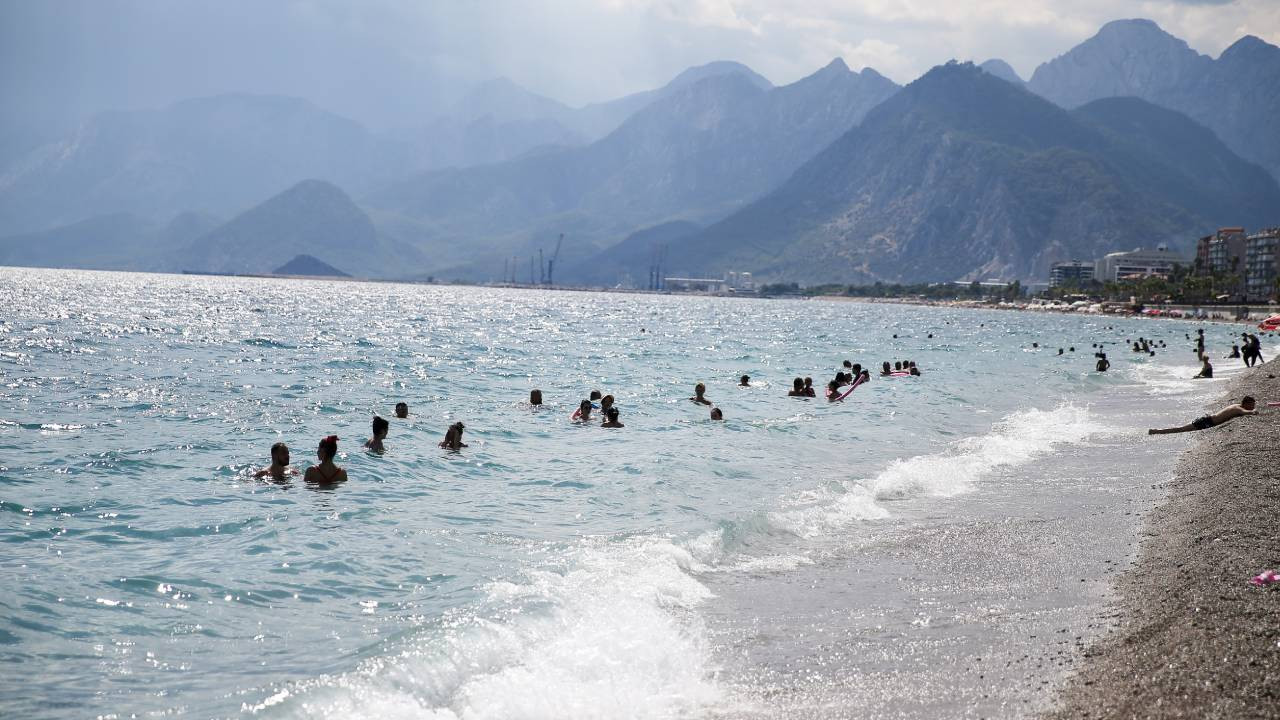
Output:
[366, 60, 897, 277]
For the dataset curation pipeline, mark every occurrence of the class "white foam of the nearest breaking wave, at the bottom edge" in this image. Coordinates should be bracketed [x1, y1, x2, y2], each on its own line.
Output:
[261, 537, 721, 720]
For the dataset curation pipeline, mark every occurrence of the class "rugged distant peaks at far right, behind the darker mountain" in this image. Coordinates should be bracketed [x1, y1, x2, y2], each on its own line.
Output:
[1028, 19, 1280, 178]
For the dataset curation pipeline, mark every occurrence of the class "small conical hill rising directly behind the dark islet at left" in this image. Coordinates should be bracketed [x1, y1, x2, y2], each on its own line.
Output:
[170, 181, 425, 277]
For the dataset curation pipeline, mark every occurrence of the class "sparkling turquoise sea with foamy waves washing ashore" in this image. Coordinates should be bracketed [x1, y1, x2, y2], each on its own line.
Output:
[0, 268, 1271, 720]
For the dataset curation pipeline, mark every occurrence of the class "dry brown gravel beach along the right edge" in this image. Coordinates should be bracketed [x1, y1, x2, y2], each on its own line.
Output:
[1046, 360, 1280, 719]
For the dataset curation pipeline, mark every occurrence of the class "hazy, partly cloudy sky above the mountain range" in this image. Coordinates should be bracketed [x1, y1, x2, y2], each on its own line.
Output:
[0, 0, 1280, 127]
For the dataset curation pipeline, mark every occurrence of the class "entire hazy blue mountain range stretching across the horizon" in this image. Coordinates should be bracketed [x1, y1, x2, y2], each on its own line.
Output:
[0, 20, 1280, 284]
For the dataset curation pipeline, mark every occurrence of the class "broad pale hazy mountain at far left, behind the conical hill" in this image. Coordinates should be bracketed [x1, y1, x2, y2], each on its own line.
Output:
[0, 95, 407, 232]
